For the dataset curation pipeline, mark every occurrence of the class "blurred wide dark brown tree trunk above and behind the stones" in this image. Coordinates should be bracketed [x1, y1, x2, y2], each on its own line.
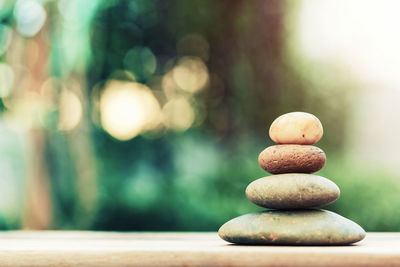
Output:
[207, 0, 304, 138]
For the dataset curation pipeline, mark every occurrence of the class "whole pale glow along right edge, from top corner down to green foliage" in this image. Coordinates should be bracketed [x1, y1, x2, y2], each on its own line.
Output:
[295, 0, 400, 168]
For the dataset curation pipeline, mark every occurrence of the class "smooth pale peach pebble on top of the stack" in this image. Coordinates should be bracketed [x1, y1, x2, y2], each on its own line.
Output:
[269, 112, 324, 145]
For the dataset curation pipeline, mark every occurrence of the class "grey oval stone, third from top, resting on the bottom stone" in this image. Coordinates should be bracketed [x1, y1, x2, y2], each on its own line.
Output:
[246, 173, 340, 209]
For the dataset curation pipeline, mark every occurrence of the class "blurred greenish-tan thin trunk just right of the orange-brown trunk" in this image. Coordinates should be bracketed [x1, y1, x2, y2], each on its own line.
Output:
[48, 1, 99, 229]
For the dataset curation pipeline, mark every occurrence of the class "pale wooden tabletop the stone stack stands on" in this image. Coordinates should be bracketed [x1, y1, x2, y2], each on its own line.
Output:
[0, 231, 400, 266]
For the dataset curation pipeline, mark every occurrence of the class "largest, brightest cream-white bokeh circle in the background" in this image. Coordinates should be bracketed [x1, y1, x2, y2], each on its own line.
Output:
[100, 80, 161, 141]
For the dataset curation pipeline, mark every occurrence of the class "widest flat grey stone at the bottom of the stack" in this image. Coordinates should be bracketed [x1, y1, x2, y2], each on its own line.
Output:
[218, 209, 365, 245]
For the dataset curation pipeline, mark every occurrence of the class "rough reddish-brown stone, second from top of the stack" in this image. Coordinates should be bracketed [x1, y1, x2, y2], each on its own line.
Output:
[258, 145, 326, 174]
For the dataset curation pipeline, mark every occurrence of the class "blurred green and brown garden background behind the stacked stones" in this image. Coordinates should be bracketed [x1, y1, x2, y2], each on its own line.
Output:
[0, 0, 400, 231]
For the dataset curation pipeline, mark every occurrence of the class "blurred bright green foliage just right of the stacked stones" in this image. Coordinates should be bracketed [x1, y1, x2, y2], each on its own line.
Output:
[320, 155, 400, 231]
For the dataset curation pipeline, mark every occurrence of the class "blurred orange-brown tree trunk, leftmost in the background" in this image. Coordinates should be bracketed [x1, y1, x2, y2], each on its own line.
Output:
[18, 25, 53, 229]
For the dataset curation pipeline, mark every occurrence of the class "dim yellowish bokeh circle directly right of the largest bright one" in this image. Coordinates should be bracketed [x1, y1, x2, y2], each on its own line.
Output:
[163, 96, 195, 131]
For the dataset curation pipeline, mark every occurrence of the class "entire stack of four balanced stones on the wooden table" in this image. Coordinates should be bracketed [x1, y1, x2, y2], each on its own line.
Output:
[218, 112, 365, 245]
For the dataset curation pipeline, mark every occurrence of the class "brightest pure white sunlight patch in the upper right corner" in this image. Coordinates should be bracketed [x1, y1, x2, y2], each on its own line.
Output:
[297, 0, 400, 84]
